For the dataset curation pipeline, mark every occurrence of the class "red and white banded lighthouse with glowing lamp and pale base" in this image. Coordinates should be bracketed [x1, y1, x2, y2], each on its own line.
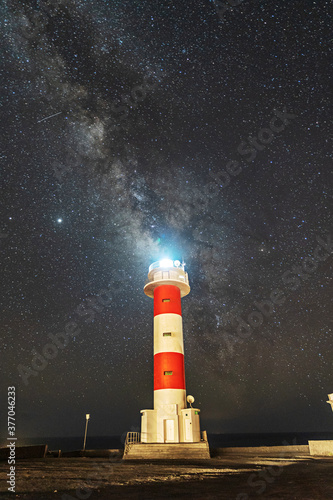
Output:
[141, 259, 201, 443]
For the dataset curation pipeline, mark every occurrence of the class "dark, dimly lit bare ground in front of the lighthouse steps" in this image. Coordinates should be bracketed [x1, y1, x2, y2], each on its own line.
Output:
[0, 456, 333, 500]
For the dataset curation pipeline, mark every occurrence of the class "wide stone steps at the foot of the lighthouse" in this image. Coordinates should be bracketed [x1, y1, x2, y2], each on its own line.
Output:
[123, 441, 210, 460]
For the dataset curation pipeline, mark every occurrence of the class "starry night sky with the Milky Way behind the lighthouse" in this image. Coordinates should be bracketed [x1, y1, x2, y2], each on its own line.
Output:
[0, 0, 333, 439]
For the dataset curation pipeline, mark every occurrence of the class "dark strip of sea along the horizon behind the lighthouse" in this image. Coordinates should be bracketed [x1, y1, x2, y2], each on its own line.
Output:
[0, 432, 333, 451]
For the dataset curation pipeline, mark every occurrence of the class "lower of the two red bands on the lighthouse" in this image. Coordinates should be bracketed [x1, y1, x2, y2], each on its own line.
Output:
[154, 352, 185, 391]
